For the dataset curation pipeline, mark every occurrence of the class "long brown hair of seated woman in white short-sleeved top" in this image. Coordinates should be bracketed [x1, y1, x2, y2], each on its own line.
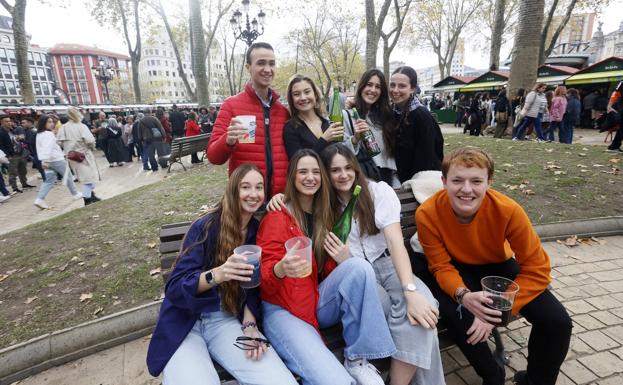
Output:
[320, 143, 380, 237]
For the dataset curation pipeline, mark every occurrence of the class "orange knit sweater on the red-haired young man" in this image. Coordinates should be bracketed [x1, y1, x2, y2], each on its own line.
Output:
[415, 189, 551, 314]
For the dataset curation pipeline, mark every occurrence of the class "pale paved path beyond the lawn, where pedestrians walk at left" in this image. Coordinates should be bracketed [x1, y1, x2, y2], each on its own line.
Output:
[0, 151, 202, 234]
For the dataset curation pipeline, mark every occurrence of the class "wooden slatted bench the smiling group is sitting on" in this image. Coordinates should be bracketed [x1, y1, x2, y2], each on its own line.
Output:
[160, 190, 507, 380]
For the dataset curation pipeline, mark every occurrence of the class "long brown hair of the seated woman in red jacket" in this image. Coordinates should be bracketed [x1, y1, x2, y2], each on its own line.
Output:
[284, 148, 334, 271]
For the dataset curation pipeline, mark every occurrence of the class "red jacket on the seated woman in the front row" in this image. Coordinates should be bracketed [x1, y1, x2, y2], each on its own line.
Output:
[256, 208, 337, 329]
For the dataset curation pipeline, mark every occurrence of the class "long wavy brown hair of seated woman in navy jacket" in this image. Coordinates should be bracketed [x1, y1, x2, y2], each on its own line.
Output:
[176, 163, 264, 315]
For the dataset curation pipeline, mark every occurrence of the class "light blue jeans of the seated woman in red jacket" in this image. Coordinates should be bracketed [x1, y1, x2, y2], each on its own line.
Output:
[262, 258, 396, 385]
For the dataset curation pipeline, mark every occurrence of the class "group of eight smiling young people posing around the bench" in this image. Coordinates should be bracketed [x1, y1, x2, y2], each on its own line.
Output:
[147, 43, 572, 385]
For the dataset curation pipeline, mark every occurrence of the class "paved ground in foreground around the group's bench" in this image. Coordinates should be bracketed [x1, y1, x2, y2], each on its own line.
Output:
[13, 236, 623, 385]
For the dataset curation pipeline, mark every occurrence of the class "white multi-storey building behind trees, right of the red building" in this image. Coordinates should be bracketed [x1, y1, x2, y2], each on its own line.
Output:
[139, 29, 227, 103]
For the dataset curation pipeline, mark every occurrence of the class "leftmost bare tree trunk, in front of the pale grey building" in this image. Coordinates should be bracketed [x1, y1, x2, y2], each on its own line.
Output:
[0, 0, 35, 104]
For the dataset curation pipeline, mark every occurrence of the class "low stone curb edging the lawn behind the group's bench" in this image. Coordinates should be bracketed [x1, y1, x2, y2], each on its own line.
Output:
[0, 216, 623, 385]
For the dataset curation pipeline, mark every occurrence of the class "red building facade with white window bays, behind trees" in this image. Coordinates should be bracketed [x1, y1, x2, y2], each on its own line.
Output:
[49, 44, 132, 104]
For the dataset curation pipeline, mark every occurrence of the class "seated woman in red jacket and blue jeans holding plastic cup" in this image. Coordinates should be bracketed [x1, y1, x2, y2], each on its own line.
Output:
[257, 149, 396, 385]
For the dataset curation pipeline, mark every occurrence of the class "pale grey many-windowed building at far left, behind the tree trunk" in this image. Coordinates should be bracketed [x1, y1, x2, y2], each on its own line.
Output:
[0, 16, 55, 104]
